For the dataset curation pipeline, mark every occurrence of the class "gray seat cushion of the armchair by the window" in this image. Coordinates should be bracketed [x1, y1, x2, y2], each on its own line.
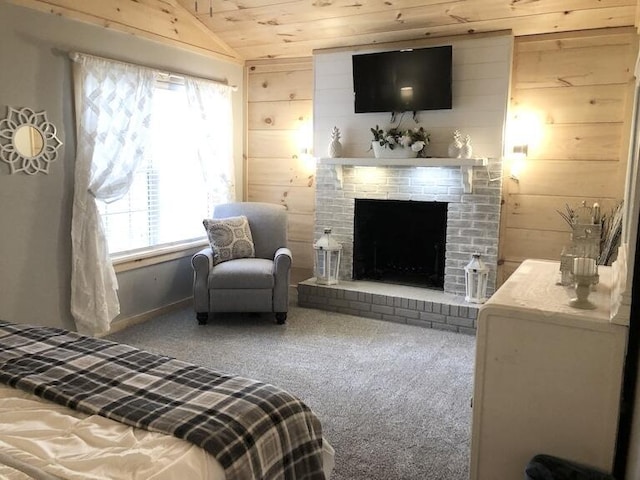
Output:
[209, 258, 275, 289]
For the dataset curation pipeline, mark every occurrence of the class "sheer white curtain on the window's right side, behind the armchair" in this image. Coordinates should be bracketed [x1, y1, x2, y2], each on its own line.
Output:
[185, 77, 235, 204]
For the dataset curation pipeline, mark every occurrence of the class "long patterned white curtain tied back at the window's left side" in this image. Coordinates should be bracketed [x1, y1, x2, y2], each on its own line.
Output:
[71, 54, 155, 335]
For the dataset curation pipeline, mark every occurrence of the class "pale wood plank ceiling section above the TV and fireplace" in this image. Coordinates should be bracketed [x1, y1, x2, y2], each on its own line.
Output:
[176, 0, 637, 60]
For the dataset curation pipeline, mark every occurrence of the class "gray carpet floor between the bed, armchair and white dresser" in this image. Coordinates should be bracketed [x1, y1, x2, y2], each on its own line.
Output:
[109, 298, 475, 480]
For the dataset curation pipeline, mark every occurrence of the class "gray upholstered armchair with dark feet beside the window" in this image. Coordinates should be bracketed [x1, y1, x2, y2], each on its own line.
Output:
[191, 202, 291, 325]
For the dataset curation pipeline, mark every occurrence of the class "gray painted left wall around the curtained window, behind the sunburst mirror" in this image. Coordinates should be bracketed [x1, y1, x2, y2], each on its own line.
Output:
[0, 1, 244, 329]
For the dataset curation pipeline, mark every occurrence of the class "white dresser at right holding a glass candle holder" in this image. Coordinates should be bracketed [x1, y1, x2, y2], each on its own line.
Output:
[471, 260, 627, 480]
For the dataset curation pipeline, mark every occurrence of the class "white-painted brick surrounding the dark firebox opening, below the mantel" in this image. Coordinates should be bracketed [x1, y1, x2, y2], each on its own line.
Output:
[315, 158, 500, 293]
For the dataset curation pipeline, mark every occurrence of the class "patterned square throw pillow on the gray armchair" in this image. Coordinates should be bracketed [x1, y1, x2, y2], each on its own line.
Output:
[202, 215, 256, 265]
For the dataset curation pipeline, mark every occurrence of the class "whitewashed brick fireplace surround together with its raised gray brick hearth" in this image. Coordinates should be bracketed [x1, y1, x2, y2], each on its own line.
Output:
[298, 159, 501, 331]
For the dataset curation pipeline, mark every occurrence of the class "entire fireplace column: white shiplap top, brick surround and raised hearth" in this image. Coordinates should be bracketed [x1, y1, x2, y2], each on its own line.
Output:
[298, 33, 513, 331]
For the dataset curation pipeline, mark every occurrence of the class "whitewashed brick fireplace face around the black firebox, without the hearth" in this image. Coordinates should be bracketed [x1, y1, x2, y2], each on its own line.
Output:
[314, 159, 501, 295]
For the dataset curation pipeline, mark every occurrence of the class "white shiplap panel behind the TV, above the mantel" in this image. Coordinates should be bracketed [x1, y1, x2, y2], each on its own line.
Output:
[313, 34, 513, 158]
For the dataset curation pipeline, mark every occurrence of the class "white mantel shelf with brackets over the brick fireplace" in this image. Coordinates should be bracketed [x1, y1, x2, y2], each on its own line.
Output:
[318, 157, 488, 193]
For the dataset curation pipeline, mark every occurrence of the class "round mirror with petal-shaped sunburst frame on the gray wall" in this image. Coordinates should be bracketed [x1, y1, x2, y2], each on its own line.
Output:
[0, 107, 62, 175]
